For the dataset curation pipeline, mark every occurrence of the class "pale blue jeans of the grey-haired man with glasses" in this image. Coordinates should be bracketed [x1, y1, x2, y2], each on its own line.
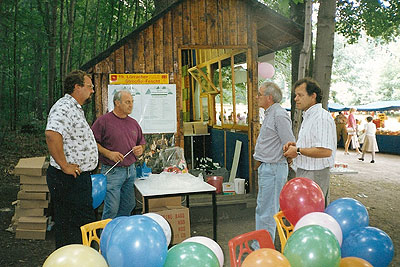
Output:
[256, 162, 289, 241]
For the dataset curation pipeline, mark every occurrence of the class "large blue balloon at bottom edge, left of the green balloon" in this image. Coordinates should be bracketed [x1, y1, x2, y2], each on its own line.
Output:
[106, 215, 167, 267]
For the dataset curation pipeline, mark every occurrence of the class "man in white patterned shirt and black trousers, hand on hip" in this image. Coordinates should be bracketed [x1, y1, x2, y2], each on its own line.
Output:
[45, 70, 98, 248]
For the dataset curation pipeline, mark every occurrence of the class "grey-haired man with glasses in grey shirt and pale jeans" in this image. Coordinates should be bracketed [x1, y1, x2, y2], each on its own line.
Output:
[253, 82, 295, 243]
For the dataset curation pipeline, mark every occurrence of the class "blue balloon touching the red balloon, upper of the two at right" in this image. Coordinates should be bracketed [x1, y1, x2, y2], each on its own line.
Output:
[325, 198, 369, 240]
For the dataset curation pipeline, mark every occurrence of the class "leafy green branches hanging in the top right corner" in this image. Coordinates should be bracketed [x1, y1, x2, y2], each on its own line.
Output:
[336, 0, 400, 43]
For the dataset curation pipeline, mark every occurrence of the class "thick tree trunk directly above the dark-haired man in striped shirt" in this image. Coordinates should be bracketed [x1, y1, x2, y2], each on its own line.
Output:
[313, 0, 336, 109]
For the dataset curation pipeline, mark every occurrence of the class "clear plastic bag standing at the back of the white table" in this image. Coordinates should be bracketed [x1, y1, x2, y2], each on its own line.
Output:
[160, 146, 188, 173]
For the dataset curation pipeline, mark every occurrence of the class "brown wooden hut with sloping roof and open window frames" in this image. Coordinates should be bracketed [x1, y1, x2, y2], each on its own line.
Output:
[81, 0, 303, 194]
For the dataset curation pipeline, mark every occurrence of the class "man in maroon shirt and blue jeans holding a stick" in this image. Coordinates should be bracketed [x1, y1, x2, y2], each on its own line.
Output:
[92, 90, 146, 220]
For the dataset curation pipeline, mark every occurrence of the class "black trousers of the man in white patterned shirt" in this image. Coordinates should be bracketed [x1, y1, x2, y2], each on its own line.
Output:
[47, 166, 95, 248]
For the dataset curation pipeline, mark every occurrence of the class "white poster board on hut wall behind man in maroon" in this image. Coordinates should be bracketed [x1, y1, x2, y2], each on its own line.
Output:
[108, 84, 177, 134]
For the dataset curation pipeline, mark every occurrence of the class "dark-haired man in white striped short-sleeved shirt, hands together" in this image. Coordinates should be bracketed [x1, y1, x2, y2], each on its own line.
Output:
[283, 78, 336, 204]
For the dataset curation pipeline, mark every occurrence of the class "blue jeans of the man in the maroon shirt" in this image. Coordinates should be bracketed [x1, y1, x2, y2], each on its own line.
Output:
[101, 164, 136, 220]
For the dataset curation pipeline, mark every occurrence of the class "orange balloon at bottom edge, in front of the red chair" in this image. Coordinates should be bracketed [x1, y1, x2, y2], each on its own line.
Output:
[241, 248, 290, 267]
